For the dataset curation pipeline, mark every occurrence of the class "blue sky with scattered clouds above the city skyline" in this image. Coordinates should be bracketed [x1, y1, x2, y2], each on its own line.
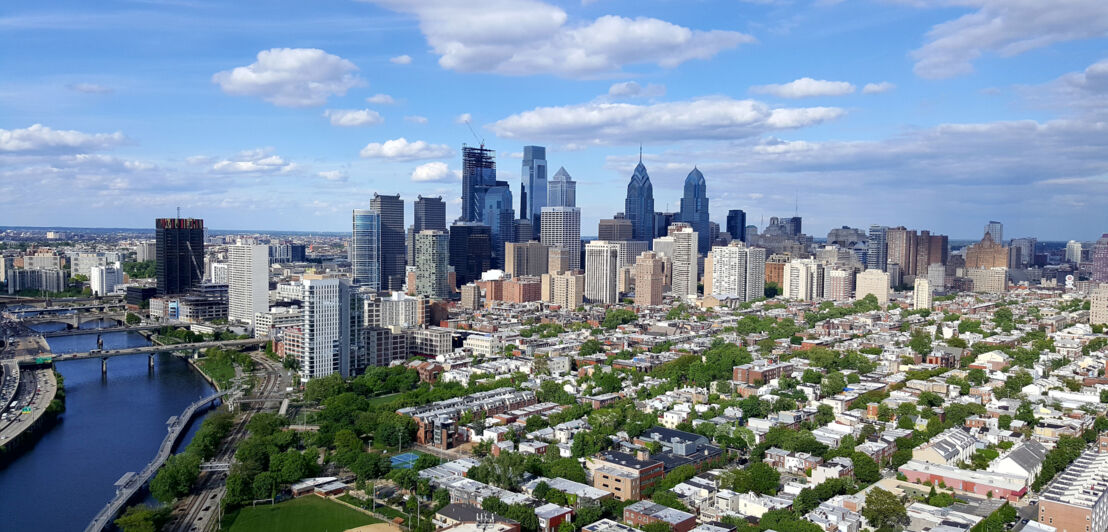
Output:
[0, 0, 1108, 239]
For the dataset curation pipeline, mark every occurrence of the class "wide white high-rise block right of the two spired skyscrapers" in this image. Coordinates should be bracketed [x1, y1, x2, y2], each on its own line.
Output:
[704, 241, 766, 301]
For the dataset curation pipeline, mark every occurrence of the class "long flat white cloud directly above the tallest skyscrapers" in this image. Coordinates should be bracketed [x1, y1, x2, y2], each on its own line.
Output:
[490, 98, 844, 146]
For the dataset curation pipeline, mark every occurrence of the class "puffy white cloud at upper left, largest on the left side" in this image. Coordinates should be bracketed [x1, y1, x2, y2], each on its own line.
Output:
[212, 48, 363, 108]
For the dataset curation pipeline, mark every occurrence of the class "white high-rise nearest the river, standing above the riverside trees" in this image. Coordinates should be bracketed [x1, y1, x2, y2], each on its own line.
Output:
[298, 274, 343, 381]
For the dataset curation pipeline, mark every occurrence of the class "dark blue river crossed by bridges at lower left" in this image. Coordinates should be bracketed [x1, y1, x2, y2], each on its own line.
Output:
[0, 323, 213, 531]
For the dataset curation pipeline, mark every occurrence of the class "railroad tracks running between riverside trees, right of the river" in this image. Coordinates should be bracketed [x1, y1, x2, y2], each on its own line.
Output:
[163, 356, 281, 532]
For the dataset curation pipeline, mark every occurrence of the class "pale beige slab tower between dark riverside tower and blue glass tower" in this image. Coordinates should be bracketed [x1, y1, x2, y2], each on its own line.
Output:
[227, 244, 269, 327]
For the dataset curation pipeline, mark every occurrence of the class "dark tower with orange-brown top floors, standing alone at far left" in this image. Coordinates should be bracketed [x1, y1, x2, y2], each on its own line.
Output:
[154, 218, 204, 296]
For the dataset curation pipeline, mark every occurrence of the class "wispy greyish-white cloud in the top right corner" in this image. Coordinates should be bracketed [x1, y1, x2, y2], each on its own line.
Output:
[909, 0, 1108, 79]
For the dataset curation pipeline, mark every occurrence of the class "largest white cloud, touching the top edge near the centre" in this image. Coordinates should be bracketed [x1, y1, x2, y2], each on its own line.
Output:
[358, 0, 756, 78]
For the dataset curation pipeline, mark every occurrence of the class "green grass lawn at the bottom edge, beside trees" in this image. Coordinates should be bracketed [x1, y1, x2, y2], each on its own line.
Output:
[226, 495, 381, 532]
